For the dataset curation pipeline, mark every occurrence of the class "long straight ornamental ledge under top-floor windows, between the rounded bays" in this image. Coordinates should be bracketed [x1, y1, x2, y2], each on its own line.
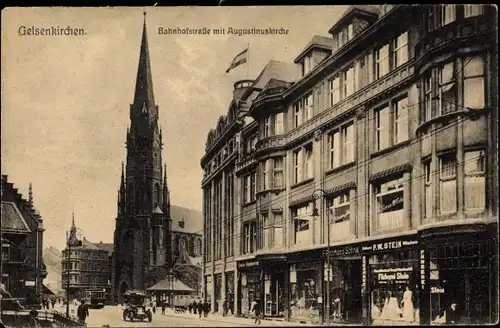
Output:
[284, 60, 414, 144]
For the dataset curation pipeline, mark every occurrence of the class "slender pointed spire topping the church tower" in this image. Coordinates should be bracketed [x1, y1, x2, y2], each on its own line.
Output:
[134, 12, 155, 109]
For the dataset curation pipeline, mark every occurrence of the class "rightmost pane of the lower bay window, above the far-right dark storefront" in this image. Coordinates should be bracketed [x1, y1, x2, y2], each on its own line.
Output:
[464, 150, 486, 210]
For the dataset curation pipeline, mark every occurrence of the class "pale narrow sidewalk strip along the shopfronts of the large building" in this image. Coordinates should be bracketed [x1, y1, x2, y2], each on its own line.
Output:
[162, 309, 317, 327]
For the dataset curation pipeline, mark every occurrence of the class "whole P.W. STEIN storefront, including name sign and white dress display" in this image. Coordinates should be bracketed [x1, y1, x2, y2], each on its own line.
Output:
[361, 235, 421, 325]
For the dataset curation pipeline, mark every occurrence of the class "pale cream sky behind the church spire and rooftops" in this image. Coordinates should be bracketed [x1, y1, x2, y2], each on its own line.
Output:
[1, 6, 347, 249]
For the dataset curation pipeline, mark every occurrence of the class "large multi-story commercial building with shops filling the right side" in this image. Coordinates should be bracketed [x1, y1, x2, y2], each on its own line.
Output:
[202, 5, 498, 324]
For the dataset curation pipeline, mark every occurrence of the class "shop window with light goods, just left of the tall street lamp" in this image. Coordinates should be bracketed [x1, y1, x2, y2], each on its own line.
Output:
[289, 260, 323, 323]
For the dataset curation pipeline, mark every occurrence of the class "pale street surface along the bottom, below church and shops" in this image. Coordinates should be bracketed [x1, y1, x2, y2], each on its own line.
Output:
[54, 305, 296, 327]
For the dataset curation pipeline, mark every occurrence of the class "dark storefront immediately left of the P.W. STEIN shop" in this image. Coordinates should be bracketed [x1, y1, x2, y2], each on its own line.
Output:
[323, 245, 363, 323]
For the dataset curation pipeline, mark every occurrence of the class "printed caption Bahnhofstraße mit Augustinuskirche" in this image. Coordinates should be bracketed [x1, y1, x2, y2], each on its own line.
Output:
[158, 27, 289, 36]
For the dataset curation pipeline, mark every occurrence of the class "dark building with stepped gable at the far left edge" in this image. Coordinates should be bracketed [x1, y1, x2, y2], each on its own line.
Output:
[0, 175, 48, 304]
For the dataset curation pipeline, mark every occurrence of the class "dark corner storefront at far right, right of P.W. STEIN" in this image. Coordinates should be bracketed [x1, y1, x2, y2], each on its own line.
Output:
[421, 224, 498, 325]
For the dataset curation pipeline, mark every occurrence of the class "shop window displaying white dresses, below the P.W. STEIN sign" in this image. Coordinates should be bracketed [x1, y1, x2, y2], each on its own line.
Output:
[368, 250, 420, 325]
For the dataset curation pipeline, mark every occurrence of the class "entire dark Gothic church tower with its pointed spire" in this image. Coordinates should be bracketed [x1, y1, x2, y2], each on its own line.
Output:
[112, 13, 171, 302]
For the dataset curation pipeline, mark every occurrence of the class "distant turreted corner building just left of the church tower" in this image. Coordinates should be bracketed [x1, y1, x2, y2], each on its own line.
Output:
[61, 217, 112, 302]
